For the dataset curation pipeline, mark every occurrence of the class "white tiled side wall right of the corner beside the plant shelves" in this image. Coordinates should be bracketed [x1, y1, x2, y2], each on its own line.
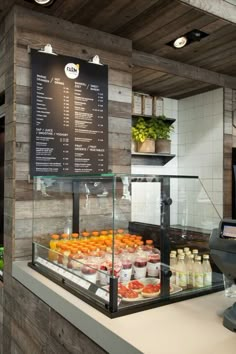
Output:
[178, 88, 223, 227]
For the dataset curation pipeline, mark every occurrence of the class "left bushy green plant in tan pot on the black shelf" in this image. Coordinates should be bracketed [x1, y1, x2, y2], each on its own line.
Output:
[132, 117, 156, 153]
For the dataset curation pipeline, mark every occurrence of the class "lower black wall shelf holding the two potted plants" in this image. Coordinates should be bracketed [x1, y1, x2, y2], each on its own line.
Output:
[131, 152, 175, 166]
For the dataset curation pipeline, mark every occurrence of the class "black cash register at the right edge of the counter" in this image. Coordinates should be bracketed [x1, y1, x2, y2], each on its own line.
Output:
[209, 219, 236, 332]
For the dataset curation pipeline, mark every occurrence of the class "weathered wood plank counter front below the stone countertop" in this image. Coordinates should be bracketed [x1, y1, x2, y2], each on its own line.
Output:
[0, 277, 105, 354]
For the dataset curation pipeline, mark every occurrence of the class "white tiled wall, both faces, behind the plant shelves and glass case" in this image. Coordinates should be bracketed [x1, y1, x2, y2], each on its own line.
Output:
[132, 88, 223, 228]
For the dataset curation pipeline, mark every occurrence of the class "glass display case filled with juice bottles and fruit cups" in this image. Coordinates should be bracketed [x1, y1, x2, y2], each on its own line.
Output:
[30, 174, 223, 317]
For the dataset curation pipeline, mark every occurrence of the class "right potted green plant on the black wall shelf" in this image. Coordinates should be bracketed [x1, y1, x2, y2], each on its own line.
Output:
[156, 116, 174, 154]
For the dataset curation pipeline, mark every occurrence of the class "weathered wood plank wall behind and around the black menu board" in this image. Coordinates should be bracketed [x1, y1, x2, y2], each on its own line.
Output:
[12, 7, 132, 259]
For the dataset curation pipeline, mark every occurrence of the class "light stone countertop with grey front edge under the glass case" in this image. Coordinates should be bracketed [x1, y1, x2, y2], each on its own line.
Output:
[13, 262, 236, 354]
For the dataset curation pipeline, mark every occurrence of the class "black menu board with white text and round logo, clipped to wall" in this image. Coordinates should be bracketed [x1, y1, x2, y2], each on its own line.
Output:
[31, 50, 108, 177]
